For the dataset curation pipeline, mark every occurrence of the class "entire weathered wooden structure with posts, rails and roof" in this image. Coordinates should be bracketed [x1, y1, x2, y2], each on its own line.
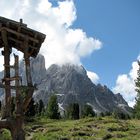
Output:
[0, 17, 46, 140]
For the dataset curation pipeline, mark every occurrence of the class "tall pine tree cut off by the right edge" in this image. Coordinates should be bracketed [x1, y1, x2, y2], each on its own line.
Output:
[134, 61, 140, 119]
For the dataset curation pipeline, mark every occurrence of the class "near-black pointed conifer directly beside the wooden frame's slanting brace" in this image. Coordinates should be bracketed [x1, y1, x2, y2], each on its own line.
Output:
[25, 98, 36, 117]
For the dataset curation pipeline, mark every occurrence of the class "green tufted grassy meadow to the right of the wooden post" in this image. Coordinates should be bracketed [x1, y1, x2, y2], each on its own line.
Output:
[25, 117, 140, 140]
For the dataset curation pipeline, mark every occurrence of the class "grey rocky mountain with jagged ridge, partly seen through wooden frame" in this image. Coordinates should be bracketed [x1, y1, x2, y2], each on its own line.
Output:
[0, 55, 131, 113]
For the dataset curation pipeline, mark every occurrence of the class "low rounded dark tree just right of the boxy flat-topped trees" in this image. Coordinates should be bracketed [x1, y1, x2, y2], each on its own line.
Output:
[82, 104, 96, 117]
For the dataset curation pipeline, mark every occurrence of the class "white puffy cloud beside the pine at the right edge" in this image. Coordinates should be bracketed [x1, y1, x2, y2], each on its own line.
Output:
[113, 57, 138, 107]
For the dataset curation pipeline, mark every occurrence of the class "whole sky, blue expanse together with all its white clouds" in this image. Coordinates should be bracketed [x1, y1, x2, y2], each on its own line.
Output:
[0, 0, 140, 106]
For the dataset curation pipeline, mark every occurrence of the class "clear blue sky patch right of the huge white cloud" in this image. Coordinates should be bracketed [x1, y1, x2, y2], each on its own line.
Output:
[73, 0, 140, 88]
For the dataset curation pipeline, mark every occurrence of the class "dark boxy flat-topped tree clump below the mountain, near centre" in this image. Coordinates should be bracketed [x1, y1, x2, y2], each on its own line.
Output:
[67, 103, 79, 120]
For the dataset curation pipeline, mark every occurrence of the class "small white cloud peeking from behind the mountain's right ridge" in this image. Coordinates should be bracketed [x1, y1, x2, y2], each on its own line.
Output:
[87, 71, 99, 84]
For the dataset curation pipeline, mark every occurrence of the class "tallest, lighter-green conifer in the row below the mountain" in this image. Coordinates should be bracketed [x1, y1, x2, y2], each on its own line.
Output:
[47, 95, 60, 119]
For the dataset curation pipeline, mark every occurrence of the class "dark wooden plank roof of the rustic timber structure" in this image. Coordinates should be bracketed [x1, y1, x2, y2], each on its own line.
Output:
[0, 17, 46, 57]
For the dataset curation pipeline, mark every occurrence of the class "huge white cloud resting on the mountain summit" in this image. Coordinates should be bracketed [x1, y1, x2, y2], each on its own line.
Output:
[0, 0, 102, 72]
